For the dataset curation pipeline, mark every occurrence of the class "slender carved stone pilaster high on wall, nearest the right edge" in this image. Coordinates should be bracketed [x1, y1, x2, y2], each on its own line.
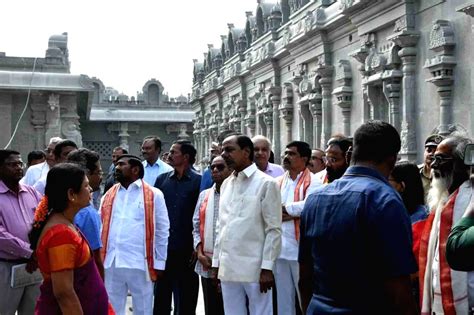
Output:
[425, 20, 456, 135]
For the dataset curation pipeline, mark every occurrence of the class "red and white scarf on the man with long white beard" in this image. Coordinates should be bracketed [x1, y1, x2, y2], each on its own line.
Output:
[419, 190, 469, 315]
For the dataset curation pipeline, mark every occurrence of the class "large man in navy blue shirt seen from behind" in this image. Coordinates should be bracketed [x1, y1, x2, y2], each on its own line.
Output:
[299, 121, 417, 314]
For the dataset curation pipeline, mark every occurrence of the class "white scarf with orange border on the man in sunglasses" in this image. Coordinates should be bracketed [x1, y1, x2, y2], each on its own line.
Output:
[199, 184, 216, 258]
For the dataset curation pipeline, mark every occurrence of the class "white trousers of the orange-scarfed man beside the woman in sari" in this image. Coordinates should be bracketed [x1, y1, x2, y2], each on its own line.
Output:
[104, 262, 153, 315]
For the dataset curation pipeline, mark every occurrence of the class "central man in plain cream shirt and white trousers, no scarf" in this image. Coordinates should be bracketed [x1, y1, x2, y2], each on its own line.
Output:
[212, 136, 282, 315]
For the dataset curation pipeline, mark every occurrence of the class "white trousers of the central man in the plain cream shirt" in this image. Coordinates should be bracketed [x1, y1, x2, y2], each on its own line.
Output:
[221, 281, 273, 315]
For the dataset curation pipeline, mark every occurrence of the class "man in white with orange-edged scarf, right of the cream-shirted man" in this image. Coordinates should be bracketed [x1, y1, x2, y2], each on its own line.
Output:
[275, 141, 321, 315]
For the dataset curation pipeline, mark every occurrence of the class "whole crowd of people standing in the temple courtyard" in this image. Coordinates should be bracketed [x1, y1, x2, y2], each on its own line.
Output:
[0, 121, 474, 315]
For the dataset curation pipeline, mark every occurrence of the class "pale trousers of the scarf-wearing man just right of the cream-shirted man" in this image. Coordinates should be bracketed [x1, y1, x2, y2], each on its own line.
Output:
[275, 259, 301, 315]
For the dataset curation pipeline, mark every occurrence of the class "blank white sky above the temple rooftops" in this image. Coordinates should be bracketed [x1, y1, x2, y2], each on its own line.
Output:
[0, 0, 257, 97]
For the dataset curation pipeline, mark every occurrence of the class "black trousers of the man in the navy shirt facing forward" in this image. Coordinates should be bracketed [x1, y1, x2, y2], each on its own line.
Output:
[153, 251, 199, 315]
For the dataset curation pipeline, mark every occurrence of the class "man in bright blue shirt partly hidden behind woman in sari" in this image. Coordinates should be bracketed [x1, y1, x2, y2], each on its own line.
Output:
[67, 149, 104, 279]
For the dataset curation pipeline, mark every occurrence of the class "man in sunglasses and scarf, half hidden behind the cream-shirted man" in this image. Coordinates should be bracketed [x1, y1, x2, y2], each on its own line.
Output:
[193, 156, 232, 315]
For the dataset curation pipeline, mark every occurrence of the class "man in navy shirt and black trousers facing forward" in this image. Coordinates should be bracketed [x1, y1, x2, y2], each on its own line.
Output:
[153, 140, 201, 314]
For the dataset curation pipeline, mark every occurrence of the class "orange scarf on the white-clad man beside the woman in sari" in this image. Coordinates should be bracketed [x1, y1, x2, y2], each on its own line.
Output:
[100, 180, 157, 281]
